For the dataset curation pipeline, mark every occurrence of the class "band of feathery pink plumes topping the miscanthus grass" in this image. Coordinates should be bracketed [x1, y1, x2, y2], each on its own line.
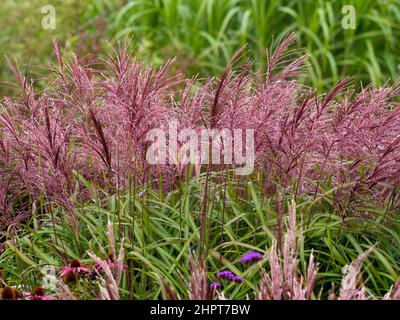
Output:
[0, 34, 400, 226]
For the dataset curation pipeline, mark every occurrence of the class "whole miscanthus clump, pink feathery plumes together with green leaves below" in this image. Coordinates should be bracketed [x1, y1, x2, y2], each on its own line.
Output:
[0, 34, 400, 299]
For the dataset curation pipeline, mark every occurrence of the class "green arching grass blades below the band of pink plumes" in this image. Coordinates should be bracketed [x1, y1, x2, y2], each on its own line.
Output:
[0, 178, 400, 299]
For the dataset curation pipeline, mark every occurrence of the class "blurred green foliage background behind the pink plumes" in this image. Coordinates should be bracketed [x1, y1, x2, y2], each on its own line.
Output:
[0, 0, 400, 96]
